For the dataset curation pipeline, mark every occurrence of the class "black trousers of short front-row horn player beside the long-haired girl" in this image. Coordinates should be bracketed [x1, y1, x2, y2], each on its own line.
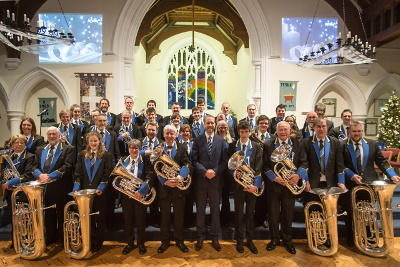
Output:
[121, 194, 147, 246]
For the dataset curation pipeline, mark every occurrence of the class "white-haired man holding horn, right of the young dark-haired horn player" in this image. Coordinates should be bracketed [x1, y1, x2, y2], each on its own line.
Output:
[263, 121, 307, 254]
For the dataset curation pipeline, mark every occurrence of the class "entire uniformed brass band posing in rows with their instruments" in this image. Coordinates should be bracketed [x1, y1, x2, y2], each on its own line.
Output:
[1, 97, 400, 259]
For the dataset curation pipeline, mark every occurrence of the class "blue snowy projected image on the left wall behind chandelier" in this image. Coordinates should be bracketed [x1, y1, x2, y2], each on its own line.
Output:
[39, 14, 103, 63]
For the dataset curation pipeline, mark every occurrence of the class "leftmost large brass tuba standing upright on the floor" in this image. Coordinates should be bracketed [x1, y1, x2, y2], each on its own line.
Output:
[11, 181, 56, 260]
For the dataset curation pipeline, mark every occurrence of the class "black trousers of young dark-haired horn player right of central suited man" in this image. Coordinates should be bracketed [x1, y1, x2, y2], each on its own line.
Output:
[234, 187, 257, 241]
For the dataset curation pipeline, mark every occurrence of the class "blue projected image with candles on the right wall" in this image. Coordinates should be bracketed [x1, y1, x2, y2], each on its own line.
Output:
[282, 18, 338, 63]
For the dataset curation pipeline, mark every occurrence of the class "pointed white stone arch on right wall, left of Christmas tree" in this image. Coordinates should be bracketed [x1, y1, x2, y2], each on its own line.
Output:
[309, 72, 367, 116]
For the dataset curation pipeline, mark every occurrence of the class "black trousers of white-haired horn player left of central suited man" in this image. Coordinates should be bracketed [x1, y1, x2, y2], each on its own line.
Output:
[160, 194, 185, 243]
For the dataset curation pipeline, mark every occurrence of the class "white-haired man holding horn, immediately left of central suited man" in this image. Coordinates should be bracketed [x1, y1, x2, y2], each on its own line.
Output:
[157, 125, 192, 253]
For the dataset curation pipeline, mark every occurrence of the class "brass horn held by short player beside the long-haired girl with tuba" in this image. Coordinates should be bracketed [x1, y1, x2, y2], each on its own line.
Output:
[111, 160, 156, 205]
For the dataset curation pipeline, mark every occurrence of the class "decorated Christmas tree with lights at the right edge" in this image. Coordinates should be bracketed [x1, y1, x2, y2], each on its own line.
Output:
[378, 94, 400, 148]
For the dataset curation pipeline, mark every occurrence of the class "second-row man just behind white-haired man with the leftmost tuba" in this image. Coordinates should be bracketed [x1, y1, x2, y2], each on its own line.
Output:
[53, 109, 84, 155]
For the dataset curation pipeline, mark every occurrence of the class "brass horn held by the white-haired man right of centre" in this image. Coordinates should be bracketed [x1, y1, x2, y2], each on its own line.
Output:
[271, 145, 306, 195]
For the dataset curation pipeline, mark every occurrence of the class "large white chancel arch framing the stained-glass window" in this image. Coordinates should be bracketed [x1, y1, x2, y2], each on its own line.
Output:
[111, 0, 272, 113]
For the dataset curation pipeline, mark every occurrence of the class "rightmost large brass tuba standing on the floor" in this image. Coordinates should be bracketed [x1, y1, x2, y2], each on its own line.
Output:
[351, 180, 400, 257]
